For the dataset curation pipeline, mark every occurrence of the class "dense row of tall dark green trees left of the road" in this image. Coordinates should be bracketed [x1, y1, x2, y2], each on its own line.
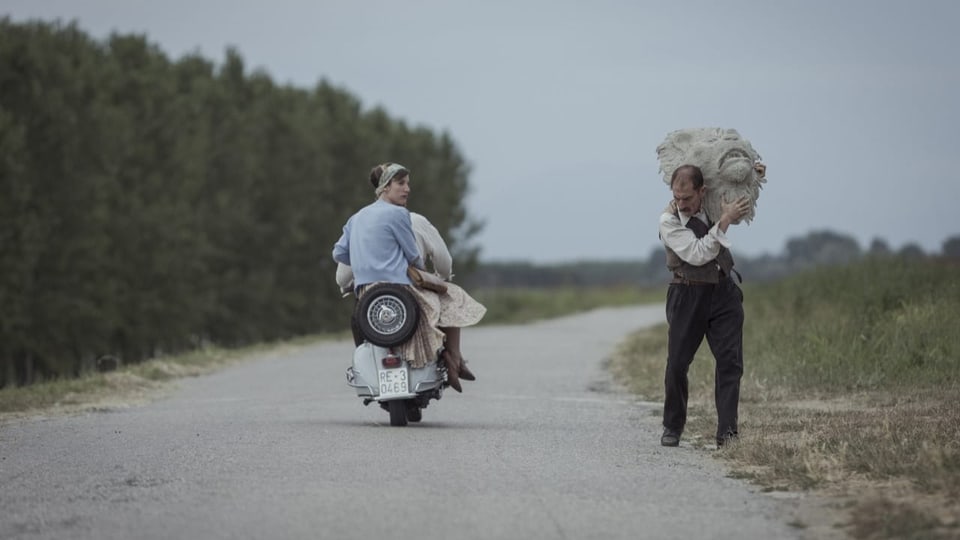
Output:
[0, 19, 479, 387]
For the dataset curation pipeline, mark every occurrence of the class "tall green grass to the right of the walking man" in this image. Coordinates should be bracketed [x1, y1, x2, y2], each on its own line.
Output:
[744, 259, 960, 392]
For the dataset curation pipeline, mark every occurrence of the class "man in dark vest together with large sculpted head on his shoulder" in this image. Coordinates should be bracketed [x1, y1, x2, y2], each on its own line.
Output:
[657, 128, 766, 446]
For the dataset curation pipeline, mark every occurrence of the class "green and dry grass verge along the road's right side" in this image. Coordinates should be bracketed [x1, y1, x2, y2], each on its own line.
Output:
[612, 260, 960, 540]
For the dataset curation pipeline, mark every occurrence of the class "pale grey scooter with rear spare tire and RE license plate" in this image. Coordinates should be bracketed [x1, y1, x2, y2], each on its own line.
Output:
[347, 283, 447, 426]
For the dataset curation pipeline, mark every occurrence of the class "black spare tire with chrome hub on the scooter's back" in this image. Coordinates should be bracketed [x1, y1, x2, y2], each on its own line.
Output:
[354, 283, 420, 347]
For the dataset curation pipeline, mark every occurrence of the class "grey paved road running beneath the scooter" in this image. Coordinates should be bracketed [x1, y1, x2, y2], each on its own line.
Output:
[0, 306, 798, 539]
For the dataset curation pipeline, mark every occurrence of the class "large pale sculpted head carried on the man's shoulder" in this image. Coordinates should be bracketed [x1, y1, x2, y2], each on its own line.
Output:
[657, 128, 767, 223]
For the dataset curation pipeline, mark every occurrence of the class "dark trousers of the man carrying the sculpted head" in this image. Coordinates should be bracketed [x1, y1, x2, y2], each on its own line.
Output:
[663, 277, 743, 438]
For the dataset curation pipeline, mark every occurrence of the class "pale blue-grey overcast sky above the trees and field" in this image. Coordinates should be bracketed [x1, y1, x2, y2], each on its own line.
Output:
[7, 0, 960, 262]
